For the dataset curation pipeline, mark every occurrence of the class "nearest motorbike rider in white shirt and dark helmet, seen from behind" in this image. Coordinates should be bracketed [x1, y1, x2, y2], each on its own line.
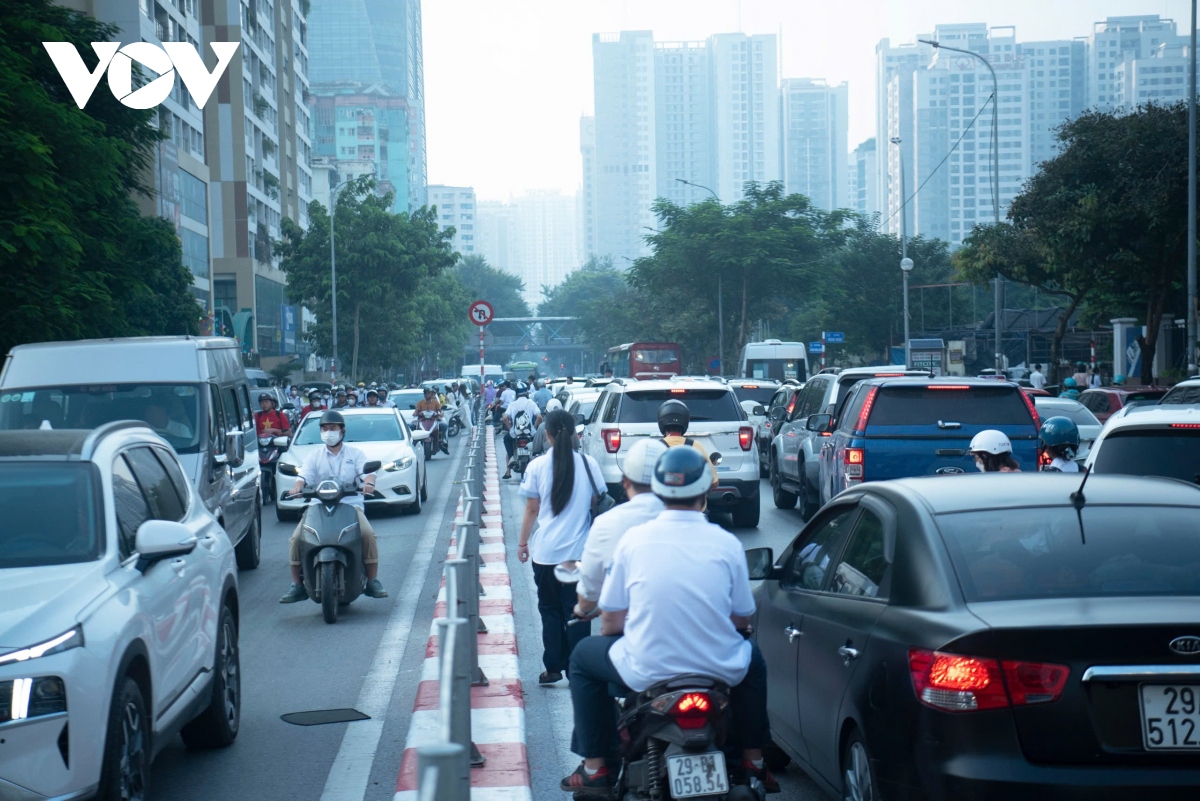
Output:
[559, 447, 779, 794]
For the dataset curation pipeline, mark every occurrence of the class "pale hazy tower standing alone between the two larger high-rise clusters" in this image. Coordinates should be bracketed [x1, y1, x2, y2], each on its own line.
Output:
[781, 78, 853, 211]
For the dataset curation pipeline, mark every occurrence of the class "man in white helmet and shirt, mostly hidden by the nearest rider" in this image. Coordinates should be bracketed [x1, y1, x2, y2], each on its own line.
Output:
[575, 439, 667, 618]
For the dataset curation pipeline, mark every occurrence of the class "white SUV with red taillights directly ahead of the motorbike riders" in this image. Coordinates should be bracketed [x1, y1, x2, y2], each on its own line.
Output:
[581, 378, 760, 528]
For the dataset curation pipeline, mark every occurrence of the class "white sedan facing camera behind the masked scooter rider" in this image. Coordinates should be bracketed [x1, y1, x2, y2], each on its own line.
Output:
[275, 409, 428, 520]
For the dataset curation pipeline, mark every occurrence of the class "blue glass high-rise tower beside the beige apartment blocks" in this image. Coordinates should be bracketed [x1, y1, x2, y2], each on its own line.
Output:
[308, 0, 427, 211]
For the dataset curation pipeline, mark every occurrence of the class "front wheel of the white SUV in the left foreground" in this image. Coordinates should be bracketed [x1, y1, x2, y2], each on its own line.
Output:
[96, 676, 150, 801]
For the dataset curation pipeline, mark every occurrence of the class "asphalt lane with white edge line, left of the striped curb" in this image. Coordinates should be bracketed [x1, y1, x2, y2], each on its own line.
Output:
[150, 436, 466, 801]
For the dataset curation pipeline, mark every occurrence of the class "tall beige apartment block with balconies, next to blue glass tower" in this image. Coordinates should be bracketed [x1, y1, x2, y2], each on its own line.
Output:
[203, 0, 312, 365]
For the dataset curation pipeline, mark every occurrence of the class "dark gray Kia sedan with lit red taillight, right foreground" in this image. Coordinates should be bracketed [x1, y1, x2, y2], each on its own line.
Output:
[748, 474, 1200, 801]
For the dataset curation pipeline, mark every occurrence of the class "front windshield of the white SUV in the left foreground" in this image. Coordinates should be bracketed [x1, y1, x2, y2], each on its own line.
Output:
[0, 462, 104, 570]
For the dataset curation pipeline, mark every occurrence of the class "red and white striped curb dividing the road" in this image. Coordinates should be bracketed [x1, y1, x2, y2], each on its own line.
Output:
[395, 427, 533, 801]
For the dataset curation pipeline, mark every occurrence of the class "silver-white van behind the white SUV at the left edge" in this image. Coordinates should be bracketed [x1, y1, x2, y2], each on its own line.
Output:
[0, 337, 263, 570]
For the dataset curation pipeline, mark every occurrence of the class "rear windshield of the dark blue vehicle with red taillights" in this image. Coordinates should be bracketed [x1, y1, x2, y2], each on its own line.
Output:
[868, 386, 1033, 426]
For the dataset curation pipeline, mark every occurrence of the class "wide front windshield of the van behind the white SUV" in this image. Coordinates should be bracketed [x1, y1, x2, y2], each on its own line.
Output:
[0, 384, 202, 453]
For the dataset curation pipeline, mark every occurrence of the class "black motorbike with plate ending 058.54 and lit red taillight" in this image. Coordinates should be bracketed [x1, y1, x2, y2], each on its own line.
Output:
[609, 675, 766, 801]
